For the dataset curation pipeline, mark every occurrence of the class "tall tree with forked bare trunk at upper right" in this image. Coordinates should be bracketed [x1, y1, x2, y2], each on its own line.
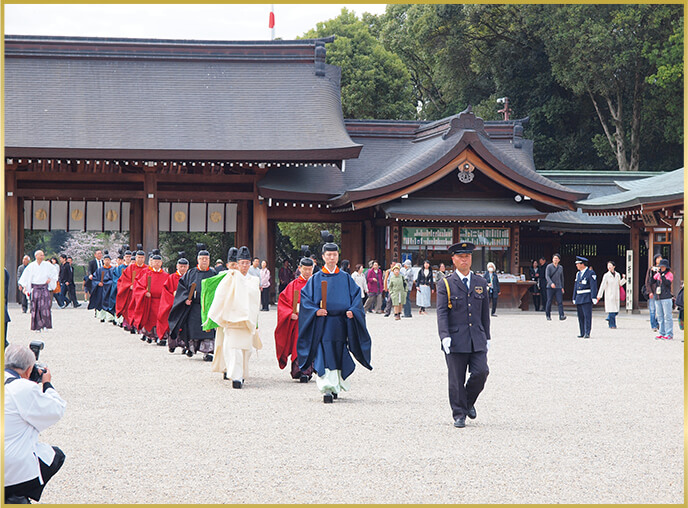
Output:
[531, 4, 682, 171]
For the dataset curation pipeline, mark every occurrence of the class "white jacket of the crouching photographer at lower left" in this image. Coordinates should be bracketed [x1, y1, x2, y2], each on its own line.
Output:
[5, 371, 67, 485]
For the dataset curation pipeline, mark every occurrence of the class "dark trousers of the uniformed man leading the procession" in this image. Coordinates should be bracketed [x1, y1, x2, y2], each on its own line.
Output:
[444, 351, 490, 420]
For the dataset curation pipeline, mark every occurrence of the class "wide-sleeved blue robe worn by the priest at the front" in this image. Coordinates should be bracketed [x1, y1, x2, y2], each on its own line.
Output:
[297, 270, 372, 379]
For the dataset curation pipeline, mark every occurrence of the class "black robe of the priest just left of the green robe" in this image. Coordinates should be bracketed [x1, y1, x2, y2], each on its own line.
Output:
[169, 266, 217, 353]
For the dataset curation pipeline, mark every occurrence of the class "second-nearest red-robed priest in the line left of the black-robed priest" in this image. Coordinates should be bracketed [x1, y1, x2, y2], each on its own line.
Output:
[131, 249, 169, 346]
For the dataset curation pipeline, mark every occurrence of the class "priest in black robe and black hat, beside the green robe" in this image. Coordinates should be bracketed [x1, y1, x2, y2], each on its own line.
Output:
[168, 244, 217, 362]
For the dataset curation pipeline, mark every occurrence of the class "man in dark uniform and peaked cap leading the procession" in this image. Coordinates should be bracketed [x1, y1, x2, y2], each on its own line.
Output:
[437, 242, 490, 428]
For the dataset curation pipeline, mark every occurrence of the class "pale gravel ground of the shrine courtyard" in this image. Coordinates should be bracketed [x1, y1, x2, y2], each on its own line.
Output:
[8, 304, 684, 504]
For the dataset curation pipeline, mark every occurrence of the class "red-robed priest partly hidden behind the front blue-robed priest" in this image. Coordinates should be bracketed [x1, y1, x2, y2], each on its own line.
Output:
[275, 253, 313, 383]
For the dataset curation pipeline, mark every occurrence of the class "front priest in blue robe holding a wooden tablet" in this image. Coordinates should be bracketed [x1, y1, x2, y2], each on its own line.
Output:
[296, 235, 372, 404]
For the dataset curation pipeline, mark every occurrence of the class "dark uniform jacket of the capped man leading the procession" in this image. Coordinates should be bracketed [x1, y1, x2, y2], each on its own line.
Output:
[437, 271, 490, 353]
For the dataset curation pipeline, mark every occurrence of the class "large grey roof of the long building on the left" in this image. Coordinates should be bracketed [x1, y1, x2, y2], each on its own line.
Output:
[5, 36, 360, 161]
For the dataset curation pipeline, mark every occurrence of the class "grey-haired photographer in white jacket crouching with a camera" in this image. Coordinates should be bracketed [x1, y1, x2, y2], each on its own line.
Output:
[5, 344, 67, 504]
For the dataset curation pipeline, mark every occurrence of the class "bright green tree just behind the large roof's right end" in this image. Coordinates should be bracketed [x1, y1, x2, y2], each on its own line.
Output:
[303, 8, 415, 119]
